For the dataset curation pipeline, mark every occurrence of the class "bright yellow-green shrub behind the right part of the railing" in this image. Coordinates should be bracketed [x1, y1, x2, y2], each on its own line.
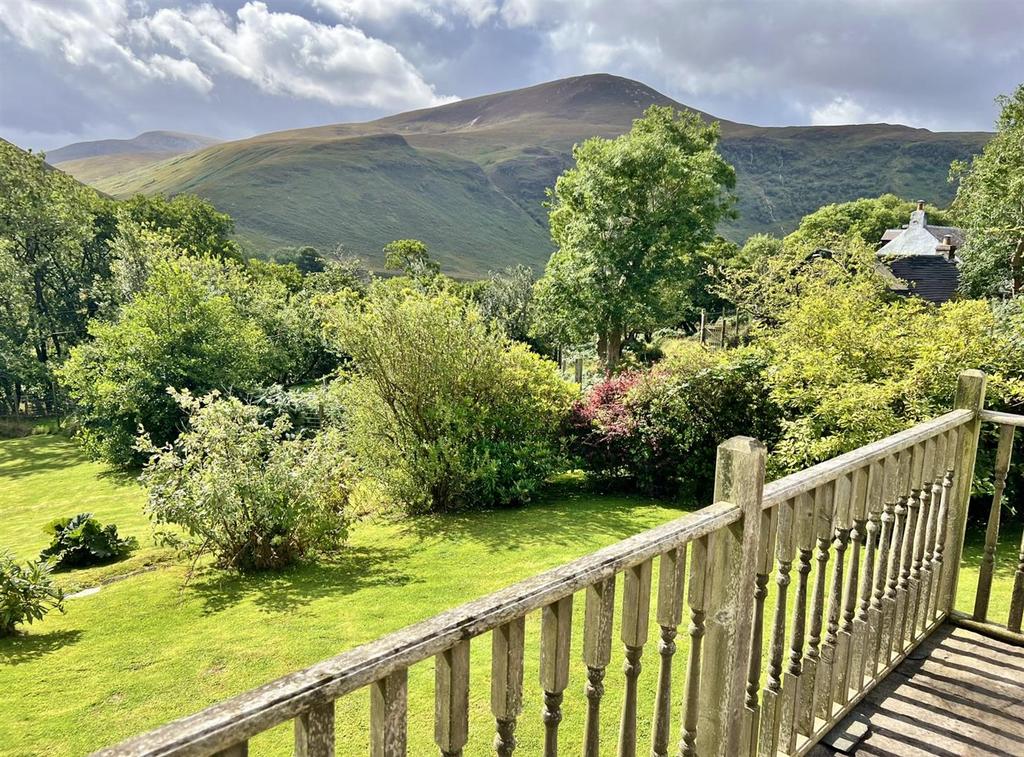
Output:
[759, 281, 1024, 470]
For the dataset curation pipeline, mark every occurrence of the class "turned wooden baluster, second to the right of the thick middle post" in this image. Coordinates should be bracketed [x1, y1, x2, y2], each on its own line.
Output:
[757, 500, 796, 757]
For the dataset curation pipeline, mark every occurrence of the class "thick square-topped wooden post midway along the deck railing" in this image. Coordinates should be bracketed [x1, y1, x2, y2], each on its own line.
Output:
[696, 436, 765, 756]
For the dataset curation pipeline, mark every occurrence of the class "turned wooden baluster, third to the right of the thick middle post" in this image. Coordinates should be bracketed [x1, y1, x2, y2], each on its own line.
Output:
[778, 494, 814, 754]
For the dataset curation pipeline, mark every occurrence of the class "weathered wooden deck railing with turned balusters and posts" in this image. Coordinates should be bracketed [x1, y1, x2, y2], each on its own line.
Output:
[92, 372, 1024, 757]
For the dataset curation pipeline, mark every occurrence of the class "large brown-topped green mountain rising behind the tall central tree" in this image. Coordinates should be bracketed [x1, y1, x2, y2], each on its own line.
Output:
[61, 74, 990, 276]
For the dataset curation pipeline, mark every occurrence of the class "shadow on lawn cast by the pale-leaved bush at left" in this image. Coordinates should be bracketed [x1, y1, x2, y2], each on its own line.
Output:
[188, 547, 416, 615]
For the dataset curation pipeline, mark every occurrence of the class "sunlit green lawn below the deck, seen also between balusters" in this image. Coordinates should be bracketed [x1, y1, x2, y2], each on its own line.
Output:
[0, 436, 1019, 755]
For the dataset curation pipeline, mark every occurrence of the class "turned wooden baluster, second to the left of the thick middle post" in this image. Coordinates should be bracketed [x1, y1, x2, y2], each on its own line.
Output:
[651, 544, 686, 757]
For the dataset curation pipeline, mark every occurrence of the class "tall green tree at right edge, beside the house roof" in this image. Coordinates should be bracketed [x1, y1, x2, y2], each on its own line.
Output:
[950, 84, 1024, 297]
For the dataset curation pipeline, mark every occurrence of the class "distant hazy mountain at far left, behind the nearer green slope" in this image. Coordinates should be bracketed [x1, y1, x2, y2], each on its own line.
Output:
[46, 131, 220, 183]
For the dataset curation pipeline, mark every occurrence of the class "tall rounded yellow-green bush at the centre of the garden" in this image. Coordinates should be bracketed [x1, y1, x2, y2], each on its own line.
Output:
[328, 284, 574, 512]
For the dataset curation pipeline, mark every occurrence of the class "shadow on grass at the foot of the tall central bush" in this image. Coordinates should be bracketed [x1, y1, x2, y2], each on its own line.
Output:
[406, 487, 697, 552]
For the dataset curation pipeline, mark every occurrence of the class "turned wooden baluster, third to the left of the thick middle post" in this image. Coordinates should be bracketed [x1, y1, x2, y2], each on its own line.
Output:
[618, 560, 651, 757]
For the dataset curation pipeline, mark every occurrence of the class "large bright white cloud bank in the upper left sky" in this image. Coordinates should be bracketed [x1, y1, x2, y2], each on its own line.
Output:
[0, 0, 452, 109]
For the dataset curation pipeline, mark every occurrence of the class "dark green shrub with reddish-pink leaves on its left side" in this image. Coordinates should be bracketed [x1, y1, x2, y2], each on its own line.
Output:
[569, 344, 779, 500]
